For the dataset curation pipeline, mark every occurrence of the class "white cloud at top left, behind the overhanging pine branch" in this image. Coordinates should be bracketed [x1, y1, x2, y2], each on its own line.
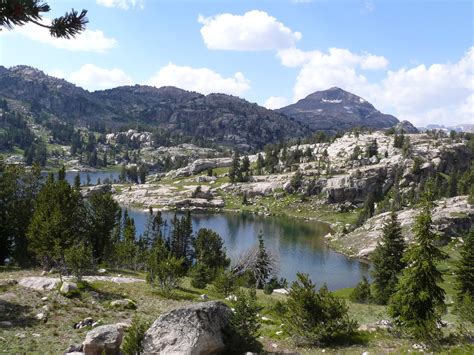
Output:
[0, 19, 117, 53]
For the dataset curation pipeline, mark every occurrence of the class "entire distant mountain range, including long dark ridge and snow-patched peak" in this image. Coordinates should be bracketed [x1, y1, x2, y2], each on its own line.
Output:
[0, 66, 412, 149]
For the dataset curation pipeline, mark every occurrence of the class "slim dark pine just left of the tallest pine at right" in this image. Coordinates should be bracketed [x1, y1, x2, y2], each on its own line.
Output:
[372, 211, 406, 304]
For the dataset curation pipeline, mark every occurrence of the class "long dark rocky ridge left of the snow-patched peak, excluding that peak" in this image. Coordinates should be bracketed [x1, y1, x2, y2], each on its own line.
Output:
[0, 66, 311, 149]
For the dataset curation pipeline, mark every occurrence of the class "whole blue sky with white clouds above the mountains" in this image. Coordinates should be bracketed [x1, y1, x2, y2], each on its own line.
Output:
[0, 0, 474, 126]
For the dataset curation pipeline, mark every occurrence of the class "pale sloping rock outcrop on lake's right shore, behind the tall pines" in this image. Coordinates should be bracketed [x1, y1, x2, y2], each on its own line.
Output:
[329, 196, 474, 258]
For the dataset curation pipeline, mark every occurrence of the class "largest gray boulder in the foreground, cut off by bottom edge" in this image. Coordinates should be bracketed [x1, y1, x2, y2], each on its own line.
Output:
[143, 301, 232, 355]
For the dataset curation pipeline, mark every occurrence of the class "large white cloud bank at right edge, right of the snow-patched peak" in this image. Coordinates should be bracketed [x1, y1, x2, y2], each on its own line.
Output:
[374, 47, 474, 124]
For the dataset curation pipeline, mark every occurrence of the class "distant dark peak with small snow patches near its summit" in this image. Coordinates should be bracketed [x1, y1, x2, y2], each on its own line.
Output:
[276, 87, 399, 131]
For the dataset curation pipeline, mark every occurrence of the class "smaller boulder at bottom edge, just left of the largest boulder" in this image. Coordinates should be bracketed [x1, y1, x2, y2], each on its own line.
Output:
[82, 324, 123, 355]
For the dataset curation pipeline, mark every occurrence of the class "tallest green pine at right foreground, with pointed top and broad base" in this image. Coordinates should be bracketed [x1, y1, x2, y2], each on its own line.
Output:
[388, 204, 446, 340]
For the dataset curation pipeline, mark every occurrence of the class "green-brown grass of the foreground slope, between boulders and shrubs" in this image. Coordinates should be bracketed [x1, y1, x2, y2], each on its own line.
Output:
[0, 258, 474, 354]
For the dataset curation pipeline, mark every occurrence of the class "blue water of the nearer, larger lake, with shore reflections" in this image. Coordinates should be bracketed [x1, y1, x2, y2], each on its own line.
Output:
[129, 209, 369, 290]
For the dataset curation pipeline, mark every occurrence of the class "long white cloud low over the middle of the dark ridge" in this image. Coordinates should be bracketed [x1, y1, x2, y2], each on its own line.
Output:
[148, 63, 250, 95]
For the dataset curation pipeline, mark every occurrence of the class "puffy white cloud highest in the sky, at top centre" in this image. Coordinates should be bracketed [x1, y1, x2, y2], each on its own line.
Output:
[198, 10, 301, 51]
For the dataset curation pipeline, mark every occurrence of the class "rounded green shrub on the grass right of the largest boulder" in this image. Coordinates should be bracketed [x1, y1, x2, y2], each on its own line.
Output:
[285, 273, 357, 345]
